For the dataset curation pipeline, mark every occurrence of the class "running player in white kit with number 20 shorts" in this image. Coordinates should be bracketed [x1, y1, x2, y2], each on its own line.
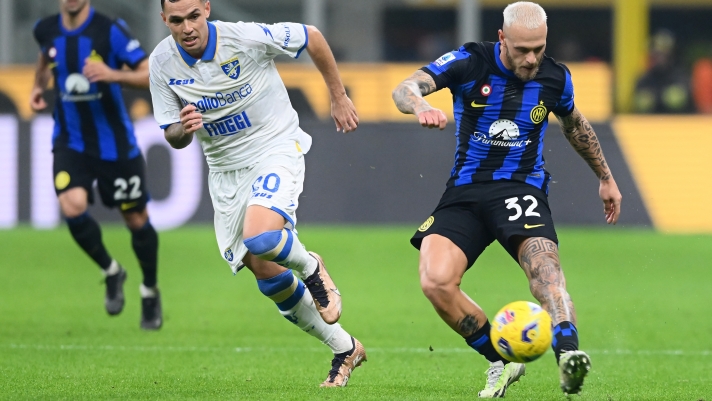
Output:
[149, 0, 366, 387]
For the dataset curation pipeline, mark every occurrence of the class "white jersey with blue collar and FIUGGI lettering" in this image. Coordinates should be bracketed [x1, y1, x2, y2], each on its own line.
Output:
[149, 21, 311, 171]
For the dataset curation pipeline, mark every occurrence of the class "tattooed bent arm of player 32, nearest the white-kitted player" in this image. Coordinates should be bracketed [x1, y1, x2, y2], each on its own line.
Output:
[393, 70, 447, 130]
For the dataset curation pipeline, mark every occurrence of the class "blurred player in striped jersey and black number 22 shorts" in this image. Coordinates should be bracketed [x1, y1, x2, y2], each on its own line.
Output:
[30, 0, 163, 330]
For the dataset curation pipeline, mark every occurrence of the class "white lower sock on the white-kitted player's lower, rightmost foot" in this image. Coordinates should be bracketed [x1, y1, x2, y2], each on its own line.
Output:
[280, 284, 353, 354]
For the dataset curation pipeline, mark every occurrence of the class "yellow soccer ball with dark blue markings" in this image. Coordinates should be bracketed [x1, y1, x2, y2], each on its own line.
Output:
[490, 301, 552, 363]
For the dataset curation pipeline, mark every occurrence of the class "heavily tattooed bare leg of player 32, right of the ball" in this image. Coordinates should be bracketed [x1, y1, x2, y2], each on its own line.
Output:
[519, 234, 576, 325]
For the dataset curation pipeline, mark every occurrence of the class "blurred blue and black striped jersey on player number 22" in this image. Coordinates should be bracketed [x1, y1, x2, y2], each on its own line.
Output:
[34, 8, 147, 161]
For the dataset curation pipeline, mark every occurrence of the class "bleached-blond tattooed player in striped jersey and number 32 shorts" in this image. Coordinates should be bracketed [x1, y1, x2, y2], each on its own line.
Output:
[393, 2, 621, 398]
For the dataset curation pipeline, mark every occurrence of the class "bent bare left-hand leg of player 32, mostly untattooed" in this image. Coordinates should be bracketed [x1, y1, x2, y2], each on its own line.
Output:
[420, 234, 487, 338]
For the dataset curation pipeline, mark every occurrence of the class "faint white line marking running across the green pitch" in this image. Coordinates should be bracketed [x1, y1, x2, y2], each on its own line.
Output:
[0, 344, 712, 356]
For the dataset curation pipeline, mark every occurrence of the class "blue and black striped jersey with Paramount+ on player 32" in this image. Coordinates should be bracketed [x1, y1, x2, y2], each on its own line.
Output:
[422, 42, 574, 192]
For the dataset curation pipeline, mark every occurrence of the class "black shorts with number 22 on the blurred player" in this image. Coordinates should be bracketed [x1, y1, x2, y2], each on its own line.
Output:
[53, 149, 150, 212]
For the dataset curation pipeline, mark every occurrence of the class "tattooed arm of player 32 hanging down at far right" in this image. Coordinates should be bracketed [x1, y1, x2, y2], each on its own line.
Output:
[556, 108, 622, 224]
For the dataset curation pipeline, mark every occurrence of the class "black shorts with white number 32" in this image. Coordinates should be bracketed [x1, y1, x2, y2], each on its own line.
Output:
[410, 180, 559, 268]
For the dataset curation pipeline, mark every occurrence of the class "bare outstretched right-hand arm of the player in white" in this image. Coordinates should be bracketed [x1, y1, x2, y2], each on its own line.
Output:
[306, 25, 358, 132]
